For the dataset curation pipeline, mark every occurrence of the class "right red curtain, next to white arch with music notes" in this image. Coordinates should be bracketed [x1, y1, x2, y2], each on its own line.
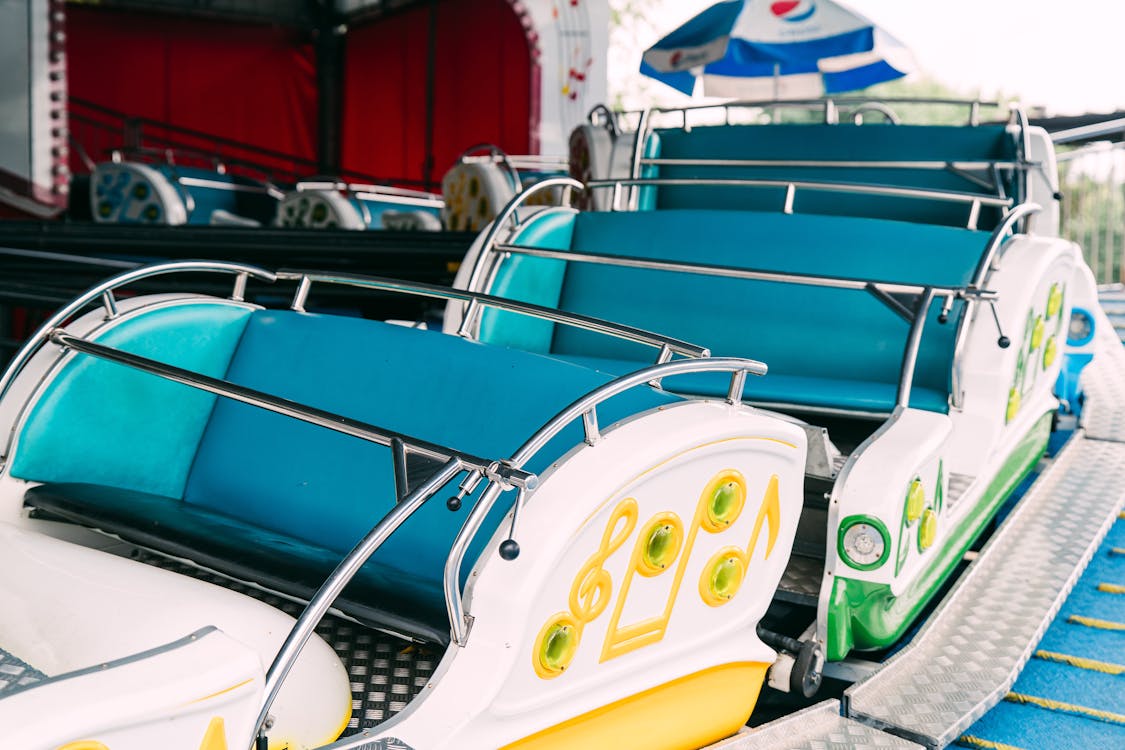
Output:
[342, 0, 533, 186]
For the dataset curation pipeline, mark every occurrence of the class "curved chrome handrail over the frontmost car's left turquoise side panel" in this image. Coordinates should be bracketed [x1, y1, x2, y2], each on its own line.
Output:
[0, 261, 277, 416]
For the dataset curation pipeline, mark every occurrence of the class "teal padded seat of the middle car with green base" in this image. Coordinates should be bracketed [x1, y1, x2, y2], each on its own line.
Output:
[482, 209, 989, 412]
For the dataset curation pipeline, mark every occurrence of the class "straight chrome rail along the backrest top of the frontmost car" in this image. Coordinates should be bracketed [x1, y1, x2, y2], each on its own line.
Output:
[277, 271, 710, 362]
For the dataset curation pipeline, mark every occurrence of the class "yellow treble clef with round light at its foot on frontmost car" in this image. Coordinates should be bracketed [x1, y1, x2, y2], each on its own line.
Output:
[532, 497, 639, 679]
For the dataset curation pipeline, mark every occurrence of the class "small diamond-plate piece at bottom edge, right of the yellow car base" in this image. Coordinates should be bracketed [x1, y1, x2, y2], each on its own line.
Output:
[707, 701, 920, 750]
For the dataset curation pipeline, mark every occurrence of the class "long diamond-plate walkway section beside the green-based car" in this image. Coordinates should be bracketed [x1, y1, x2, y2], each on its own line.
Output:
[845, 433, 1125, 748]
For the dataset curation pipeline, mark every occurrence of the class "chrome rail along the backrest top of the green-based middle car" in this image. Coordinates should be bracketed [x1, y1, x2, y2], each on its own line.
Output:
[586, 178, 1014, 229]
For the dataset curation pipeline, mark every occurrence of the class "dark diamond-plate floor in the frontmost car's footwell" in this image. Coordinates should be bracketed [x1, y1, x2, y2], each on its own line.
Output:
[133, 550, 442, 733]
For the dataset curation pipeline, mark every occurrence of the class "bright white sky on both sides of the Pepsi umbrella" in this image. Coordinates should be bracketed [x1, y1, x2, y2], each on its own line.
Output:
[610, 0, 1125, 114]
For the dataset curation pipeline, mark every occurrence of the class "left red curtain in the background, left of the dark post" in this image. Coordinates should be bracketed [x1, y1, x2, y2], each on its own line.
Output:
[66, 4, 316, 167]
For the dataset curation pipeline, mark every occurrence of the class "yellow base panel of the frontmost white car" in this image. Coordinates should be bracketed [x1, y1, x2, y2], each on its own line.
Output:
[501, 661, 770, 750]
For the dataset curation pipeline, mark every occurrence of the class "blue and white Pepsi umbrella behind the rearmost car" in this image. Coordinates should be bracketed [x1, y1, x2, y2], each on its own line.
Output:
[640, 0, 915, 99]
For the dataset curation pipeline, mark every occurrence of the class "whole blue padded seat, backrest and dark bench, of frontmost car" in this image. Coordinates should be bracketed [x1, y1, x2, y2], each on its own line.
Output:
[20, 310, 678, 642]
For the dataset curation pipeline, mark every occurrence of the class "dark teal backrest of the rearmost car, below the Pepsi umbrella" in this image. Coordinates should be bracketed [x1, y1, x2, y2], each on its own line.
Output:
[650, 125, 1016, 228]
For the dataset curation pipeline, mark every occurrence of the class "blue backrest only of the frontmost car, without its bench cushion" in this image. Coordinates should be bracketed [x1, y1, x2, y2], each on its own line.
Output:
[183, 310, 674, 588]
